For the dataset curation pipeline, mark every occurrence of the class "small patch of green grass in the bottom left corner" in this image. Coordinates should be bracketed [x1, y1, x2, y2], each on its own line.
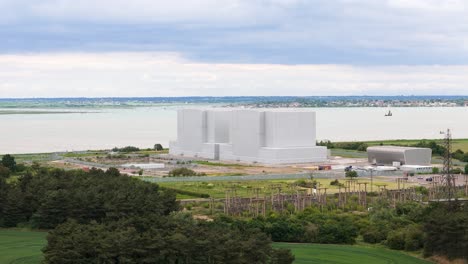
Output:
[0, 229, 47, 264]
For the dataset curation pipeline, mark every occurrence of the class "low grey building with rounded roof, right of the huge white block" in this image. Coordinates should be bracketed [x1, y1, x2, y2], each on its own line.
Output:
[367, 146, 432, 165]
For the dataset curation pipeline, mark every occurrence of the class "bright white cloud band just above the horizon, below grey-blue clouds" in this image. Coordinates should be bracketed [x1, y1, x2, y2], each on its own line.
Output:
[0, 53, 468, 98]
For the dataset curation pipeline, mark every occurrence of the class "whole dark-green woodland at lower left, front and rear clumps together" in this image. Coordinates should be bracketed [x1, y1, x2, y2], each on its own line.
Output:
[0, 164, 294, 264]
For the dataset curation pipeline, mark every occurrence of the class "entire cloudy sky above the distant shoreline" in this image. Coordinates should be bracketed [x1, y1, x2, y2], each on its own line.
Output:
[0, 0, 468, 98]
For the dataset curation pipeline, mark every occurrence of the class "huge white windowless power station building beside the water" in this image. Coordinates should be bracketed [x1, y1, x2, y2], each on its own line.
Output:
[169, 109, 328, 164]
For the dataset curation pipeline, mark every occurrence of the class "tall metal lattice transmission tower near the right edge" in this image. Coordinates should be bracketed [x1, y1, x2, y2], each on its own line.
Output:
[442, 129, 456, 201]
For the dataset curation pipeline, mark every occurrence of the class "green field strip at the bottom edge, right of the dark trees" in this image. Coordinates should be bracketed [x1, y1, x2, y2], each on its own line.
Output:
[274, 243, 431, 264]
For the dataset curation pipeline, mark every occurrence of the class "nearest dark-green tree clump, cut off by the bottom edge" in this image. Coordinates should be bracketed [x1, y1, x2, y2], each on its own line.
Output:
[44, 214, 294, 264]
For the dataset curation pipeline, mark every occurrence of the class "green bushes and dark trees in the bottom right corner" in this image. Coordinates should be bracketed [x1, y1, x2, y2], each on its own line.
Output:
[360, 202, 468, 259]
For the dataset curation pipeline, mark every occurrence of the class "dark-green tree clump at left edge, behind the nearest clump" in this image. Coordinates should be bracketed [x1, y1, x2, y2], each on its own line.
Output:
[0, 168, 177, 229]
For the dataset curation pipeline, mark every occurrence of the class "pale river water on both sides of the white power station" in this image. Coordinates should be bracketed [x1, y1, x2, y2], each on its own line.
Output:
[0, 106, 468, 154]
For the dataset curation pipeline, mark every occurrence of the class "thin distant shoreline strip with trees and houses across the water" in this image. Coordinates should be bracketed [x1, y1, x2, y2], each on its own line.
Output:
[0, 95, 468, 111]
